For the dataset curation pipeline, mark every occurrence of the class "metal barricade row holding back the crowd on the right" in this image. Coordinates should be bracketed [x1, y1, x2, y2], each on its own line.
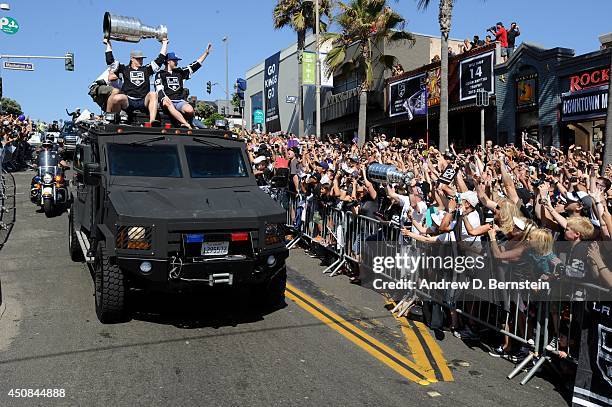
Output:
[278, 195, 609, 385]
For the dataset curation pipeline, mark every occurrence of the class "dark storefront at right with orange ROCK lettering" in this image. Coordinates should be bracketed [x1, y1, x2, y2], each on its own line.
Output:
[495, 37, 611, 149]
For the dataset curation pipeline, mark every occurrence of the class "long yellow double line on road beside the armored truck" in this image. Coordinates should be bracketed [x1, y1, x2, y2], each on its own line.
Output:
[285, 284, 436, 386]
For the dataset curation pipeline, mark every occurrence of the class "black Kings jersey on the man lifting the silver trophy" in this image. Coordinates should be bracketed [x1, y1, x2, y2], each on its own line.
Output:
[106, 51, 166, 99]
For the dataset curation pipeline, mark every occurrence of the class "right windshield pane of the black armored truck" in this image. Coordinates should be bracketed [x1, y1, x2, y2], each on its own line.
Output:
[185, 146, 249, 178]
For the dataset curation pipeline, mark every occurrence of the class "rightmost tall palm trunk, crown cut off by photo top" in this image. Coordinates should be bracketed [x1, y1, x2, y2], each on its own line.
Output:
[418, 0, 454, 151]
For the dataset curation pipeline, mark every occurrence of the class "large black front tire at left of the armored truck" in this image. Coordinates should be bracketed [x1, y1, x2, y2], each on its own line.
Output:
[94, 242, 127, 324]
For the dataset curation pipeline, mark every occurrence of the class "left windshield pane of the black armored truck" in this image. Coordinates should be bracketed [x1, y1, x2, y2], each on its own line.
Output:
[108, 144, 183, 178]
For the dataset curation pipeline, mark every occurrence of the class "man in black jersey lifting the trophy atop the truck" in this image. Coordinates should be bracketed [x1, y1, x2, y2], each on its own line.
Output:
[103, 38, 168, 123]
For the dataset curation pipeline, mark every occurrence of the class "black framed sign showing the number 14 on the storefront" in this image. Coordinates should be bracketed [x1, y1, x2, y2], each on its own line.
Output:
[459, 51, 495, 102]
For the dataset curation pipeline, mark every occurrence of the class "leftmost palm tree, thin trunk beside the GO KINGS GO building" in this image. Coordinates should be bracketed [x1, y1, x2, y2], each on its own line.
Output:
[273, 0, 332, 136]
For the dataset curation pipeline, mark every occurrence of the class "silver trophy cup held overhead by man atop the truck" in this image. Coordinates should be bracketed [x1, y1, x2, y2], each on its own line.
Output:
[102, 11, 168, 42]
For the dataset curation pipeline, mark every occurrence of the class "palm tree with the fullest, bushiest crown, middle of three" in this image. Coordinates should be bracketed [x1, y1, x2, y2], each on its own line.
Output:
[323, 0, 414, 147]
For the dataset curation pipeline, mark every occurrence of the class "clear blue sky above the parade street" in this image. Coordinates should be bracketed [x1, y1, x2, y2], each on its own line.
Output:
[0, 0, 612, 120]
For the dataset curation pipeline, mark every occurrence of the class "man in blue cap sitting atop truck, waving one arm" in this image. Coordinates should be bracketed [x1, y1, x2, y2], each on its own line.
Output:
[155, 43, 212, 129]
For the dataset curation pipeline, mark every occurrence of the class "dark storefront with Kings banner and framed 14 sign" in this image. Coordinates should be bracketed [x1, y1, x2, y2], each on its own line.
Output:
[382, 44, 501, 147]
